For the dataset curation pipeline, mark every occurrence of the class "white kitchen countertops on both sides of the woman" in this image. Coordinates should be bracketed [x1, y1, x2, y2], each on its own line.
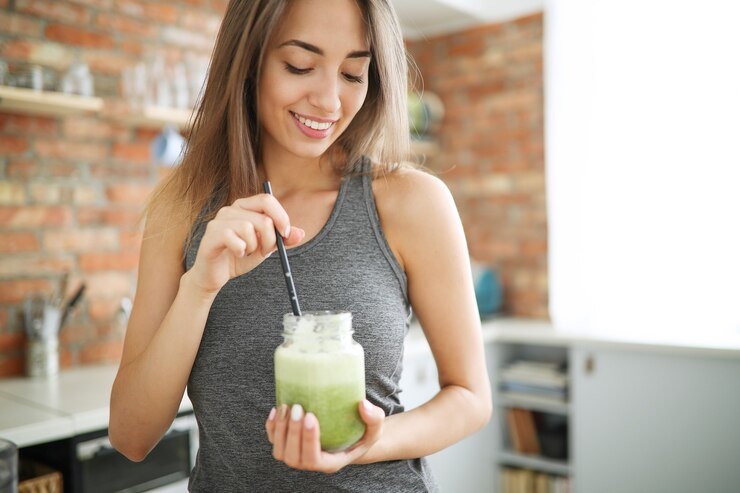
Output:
[0, 318, 740, 447]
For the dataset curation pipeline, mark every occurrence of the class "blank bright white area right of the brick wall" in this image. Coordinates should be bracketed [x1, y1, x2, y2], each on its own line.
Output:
[544, 0, 740, 337]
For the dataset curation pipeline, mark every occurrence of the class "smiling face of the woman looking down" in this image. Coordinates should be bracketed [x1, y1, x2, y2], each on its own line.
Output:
[259, 0, 370, 158]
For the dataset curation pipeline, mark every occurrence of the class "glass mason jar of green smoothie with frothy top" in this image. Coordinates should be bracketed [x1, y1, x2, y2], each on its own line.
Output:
[275, 311, 365, 452]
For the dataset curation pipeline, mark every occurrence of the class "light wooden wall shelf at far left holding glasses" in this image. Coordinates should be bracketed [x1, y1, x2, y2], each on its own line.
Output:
[0, 86, 103, 116]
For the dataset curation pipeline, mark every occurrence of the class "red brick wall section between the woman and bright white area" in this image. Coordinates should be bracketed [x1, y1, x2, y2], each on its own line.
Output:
[408, 14, 548, 318]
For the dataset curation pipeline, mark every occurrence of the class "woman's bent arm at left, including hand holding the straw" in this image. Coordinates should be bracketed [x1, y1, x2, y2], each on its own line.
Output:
[108, 195, 303, 462]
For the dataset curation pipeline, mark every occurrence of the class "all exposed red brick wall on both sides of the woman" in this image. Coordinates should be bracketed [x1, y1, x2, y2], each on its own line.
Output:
[0, 0, 547, 376]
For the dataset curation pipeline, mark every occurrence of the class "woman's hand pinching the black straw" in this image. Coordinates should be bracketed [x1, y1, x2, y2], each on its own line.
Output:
[185, 193, 306, 297]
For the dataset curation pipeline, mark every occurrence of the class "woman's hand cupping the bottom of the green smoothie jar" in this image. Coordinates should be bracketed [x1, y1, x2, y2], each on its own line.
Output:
[265, 399, 385, 473]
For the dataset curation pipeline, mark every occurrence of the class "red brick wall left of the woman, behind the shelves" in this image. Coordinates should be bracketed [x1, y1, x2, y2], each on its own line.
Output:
[0, 0, 227, 376]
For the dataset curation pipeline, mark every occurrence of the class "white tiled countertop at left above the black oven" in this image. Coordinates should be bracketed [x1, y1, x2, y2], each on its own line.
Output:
[0, 364, 192, 447]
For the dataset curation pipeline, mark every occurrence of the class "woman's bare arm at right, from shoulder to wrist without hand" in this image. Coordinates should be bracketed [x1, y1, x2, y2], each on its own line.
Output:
[355, 171, 492, 464]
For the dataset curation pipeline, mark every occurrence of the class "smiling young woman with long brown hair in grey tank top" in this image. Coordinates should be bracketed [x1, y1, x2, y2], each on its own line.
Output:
[110, 0, 491, 492]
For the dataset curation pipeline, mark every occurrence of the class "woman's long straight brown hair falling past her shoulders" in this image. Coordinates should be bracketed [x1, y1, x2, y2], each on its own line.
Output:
[144, 0, 410, 252]
